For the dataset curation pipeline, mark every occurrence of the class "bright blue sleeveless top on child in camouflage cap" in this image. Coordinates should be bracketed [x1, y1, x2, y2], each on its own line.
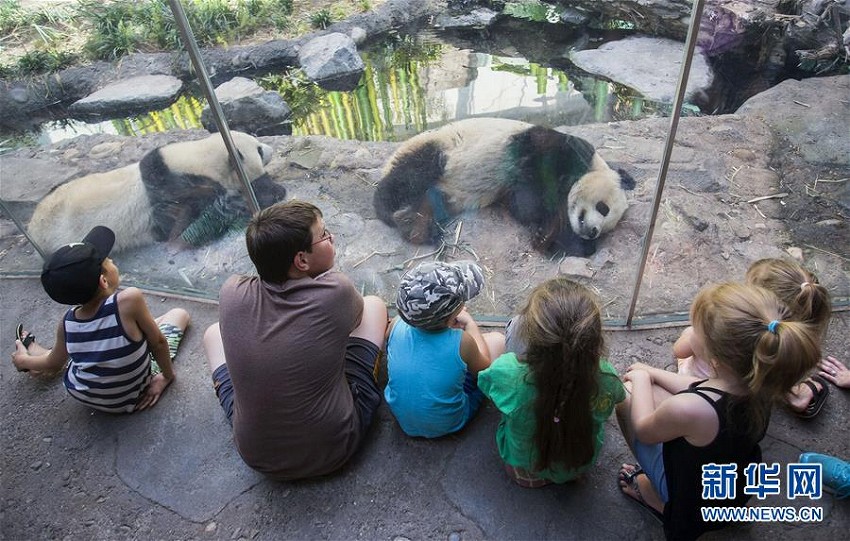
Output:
[384, 319, 475, 438]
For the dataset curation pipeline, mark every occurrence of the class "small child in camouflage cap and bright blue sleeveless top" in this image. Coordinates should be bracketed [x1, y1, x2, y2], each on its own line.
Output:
[384, 262, 505, 438]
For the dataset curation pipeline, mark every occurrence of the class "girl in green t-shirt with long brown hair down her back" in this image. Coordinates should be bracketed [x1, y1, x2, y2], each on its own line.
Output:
[478, 278, 625, 487]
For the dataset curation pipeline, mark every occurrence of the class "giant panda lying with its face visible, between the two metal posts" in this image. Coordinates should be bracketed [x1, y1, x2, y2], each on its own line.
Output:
[374, 118, 635, 256]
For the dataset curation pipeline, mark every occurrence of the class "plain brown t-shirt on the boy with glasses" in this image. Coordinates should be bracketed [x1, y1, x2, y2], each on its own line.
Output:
[219, 272, 363, 479]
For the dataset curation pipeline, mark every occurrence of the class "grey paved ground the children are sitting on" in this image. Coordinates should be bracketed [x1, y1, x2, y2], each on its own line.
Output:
[0, 278, 850, 541]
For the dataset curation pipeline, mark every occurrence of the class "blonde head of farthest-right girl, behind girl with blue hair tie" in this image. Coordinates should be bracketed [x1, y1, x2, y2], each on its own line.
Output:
[746, 258, 832, 336]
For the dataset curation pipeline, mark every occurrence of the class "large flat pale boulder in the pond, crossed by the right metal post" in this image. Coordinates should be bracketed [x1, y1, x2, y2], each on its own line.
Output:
[570, 36, 714, 103]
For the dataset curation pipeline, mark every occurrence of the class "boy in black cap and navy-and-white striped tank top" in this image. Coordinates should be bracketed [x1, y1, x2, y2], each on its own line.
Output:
[12, 226, 189, 413]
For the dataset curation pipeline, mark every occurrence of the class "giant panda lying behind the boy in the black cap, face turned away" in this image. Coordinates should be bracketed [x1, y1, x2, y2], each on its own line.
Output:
[27, 131, 286, 253]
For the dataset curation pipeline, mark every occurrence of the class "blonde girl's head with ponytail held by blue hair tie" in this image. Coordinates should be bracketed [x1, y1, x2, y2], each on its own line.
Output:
[691, 282, 820, 426]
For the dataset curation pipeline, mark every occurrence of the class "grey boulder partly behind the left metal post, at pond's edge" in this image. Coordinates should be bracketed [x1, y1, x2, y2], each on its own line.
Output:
[201, 77, 292, 136]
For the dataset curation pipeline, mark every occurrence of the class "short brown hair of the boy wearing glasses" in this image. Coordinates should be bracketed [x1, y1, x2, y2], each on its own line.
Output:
[245, 200, 322, 283]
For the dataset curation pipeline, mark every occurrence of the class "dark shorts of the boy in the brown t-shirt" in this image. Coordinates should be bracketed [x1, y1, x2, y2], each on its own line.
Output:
[212, 337, 381, 433]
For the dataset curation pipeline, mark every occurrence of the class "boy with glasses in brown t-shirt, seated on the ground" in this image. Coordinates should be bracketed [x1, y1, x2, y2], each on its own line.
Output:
[204, 201, 387, 480]
